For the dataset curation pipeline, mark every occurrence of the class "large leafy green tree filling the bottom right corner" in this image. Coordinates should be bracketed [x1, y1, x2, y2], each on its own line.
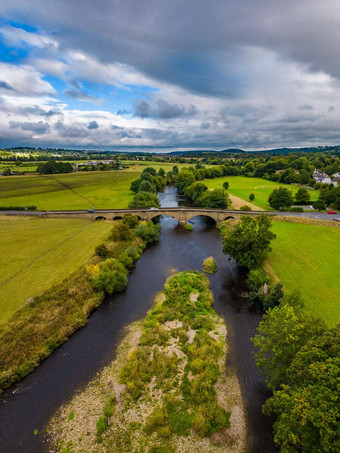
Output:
[264, 325, 340, 453]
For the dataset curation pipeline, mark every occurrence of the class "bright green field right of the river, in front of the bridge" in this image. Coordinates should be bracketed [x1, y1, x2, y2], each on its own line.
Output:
[268, 221, 340, 326]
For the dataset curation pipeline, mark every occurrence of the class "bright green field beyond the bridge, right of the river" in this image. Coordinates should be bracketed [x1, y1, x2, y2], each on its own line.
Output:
[204, 176, 319, 211]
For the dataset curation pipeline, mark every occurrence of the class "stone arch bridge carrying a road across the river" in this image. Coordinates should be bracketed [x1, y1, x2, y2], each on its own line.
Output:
[22, 207, 273, 225]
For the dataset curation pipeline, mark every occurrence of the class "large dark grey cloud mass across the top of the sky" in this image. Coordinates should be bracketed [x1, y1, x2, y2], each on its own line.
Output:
[2, 0, 340, 97]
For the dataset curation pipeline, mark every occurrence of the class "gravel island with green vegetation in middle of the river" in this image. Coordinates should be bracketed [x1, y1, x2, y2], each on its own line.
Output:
[49, 271, 246, 453]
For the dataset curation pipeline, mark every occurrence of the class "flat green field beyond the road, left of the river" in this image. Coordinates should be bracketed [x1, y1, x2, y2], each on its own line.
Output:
[0, 162, 191, 210]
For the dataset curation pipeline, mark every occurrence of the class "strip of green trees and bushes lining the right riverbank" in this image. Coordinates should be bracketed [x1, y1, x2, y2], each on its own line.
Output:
[221, 216, 340, 453]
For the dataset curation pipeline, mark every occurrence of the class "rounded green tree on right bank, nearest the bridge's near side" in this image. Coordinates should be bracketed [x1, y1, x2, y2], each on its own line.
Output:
[223, 215, 276, 269]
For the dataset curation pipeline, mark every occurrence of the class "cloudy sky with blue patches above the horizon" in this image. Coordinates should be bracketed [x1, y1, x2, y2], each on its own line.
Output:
[0, 0, 340, 152]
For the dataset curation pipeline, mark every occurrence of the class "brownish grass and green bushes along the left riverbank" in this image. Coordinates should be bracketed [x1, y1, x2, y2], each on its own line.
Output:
[0, 215, 160, 391]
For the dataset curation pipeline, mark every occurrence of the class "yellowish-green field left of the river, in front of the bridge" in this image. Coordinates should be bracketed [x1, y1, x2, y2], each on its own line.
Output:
[0, 216, 112, 322]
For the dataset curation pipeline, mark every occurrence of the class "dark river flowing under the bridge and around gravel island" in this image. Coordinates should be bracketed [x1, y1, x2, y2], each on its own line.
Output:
[0, 186, 276, 453]
